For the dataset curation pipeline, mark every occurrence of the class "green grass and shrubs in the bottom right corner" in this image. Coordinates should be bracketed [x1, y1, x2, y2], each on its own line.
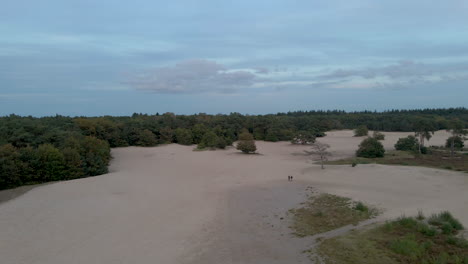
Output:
[317, 212, 468, 264]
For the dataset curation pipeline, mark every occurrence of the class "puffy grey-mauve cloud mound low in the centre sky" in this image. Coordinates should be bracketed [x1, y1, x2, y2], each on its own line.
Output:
[129, 59, 256, 93]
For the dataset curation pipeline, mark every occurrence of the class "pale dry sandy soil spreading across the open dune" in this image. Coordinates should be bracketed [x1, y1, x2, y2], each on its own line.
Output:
[0, 131, 468, 264]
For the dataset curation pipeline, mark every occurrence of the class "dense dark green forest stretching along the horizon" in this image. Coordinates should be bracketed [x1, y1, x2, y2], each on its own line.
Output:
[0, 108, 468, 189]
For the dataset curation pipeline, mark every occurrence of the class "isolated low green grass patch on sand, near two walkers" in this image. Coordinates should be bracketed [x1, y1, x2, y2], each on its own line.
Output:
[289, 194, 378, 237]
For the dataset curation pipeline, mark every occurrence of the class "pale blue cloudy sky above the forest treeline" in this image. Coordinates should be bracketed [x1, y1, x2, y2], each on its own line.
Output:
[0, 0, 468, 116]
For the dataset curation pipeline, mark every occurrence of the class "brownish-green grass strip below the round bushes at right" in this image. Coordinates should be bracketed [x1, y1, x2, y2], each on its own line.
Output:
[326, 150, 468, 172]
